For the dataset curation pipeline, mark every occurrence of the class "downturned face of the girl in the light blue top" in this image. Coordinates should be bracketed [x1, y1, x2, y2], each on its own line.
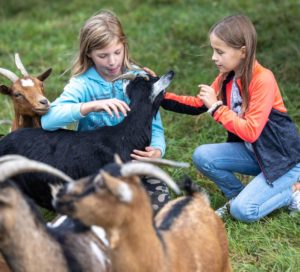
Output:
[88, 39, 124, 81]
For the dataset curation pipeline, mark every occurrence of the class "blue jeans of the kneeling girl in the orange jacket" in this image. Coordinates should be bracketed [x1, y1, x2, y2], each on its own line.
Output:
[193, 143, 300, 222]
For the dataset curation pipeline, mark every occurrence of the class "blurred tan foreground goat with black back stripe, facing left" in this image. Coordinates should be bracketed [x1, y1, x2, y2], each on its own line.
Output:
[55, 159, 231, 272]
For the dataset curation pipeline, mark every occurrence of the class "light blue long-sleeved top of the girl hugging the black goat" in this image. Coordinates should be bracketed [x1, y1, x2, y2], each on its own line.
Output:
[41, 67, 166, 156]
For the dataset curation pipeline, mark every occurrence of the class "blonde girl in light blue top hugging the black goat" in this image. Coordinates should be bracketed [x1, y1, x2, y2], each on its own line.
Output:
[41, 10, 169, 208]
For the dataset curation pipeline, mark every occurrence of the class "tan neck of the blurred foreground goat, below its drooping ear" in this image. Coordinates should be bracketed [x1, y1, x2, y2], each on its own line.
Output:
[107, 181, 168, 272]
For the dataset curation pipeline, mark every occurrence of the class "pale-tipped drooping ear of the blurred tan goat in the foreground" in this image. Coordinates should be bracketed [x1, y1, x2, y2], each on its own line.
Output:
[101, 170, 133, 203]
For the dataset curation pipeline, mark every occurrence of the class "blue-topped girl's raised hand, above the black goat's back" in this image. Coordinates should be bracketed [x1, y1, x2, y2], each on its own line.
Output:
[80, 98, 130, 118]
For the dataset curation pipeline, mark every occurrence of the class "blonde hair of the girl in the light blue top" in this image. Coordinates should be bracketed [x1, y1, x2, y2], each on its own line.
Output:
[72, 10, 132, 76]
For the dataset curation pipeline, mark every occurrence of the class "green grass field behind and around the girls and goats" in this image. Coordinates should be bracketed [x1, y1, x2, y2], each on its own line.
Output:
[0, 0, 300, 271]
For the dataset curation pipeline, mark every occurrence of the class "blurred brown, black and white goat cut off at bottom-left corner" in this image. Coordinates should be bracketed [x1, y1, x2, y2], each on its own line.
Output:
[0, 155, 111, 272]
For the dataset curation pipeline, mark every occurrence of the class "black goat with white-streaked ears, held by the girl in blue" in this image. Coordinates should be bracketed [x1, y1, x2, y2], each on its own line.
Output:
[0, 71, 174, 210]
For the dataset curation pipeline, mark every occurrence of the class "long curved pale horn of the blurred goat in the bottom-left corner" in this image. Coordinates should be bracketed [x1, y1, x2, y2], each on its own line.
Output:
[0, 159, 74, 182]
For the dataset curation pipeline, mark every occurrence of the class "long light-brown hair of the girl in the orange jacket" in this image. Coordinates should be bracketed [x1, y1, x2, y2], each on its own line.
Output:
[209, 15, 257, 112]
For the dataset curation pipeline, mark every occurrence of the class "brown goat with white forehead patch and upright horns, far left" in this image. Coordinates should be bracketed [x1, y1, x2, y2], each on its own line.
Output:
[0, 54, 52, 131]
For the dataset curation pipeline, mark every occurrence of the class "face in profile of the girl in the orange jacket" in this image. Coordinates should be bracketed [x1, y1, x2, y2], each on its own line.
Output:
[209, 33, 246, 74]
